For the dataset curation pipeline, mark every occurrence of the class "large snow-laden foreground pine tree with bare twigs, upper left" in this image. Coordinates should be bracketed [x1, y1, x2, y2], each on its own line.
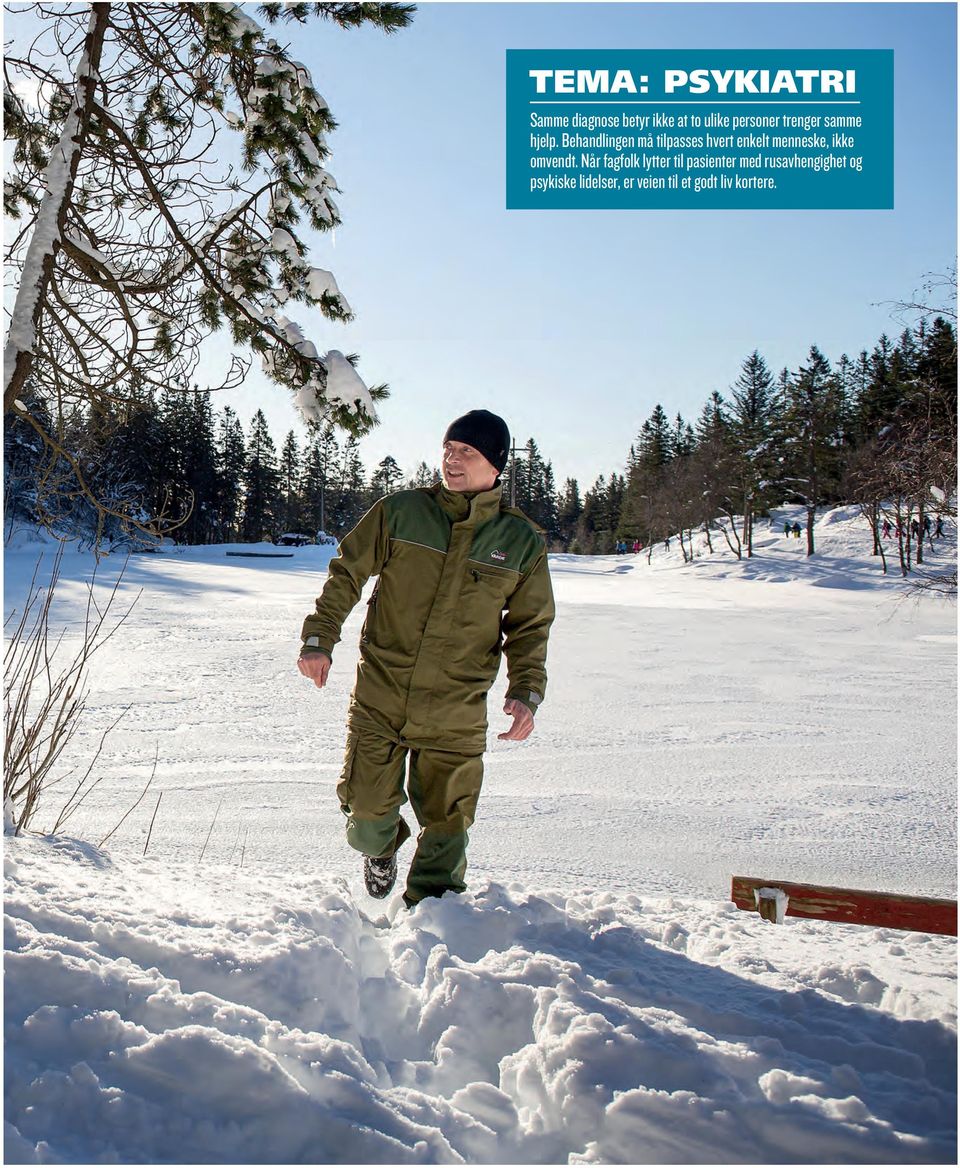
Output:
[4, 0, 412, 534]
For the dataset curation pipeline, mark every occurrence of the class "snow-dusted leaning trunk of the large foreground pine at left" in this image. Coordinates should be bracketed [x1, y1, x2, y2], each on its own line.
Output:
[4, 4, 110, 415]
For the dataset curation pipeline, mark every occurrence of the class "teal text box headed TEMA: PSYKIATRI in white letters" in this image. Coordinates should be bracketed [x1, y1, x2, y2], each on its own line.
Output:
[507, 49, 893, 210]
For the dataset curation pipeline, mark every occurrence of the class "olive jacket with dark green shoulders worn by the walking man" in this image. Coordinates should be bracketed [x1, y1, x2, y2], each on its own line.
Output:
[301, 484, 554, 750]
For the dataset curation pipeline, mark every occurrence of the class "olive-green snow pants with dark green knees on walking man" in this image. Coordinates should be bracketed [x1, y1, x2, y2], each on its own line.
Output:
[336, 726, 484, 905]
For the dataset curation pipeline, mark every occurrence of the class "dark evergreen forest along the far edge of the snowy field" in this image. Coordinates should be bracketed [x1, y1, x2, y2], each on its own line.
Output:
[4, 315, 956, 564]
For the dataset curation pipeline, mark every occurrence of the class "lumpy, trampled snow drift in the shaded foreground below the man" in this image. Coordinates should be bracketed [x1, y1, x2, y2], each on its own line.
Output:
[5, 839, 956, 1163]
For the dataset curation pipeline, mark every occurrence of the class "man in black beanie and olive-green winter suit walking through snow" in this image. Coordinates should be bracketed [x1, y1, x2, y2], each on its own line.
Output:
[298, 410, 554, 906]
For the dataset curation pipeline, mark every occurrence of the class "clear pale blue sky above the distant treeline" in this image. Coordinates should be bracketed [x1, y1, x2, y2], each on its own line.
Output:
[18, 2, 956, 487]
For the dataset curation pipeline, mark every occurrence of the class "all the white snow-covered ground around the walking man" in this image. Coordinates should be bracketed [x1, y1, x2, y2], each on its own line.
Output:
[5, 512, 956, 1163]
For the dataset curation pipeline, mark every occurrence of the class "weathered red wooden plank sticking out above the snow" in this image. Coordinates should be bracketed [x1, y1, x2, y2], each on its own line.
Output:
[730, 876, 956, 937]
